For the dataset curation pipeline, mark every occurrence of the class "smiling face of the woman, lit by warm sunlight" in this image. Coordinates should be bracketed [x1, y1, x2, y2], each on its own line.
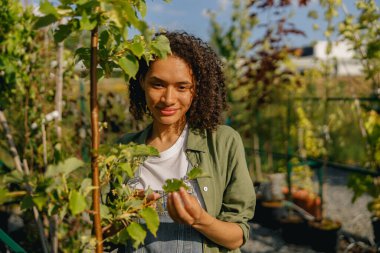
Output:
[141, 56, 195, 126]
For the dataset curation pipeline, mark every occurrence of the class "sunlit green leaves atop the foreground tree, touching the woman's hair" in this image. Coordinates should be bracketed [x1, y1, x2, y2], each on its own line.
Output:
[35, 0, 170, 81]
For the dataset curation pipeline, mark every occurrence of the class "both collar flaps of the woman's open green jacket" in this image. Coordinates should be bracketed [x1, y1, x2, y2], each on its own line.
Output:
[135, 124, 207, 152]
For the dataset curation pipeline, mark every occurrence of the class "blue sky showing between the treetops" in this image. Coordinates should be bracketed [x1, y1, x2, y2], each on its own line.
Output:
[146, 0, 358, 46]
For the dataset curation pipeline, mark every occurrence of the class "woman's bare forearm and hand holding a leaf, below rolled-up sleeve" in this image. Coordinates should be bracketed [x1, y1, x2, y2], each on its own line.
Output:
[167, 188, 243, 250]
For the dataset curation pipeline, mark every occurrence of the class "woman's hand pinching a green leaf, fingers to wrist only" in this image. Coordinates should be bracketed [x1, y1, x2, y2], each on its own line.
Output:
[167, 187, 206, 226]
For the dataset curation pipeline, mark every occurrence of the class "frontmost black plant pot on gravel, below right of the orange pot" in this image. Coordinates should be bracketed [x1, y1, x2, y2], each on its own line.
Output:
[309, 219, 342, 253]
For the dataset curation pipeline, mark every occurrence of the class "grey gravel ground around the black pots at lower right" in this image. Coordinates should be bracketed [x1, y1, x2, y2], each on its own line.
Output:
[242, 169, 380, 253]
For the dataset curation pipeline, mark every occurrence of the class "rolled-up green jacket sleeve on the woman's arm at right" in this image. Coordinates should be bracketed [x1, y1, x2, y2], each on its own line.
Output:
[217, 130, 256, 243]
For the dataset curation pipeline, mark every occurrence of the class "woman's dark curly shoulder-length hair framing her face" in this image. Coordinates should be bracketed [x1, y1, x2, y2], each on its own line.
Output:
[129, 31, 227, 130]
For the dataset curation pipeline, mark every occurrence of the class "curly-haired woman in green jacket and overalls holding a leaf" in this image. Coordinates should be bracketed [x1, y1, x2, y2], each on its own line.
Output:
[121, 32, 255, 253]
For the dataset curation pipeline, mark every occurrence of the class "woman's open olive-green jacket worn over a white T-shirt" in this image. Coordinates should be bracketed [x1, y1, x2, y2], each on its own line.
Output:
[120, 125, 256, 253]
